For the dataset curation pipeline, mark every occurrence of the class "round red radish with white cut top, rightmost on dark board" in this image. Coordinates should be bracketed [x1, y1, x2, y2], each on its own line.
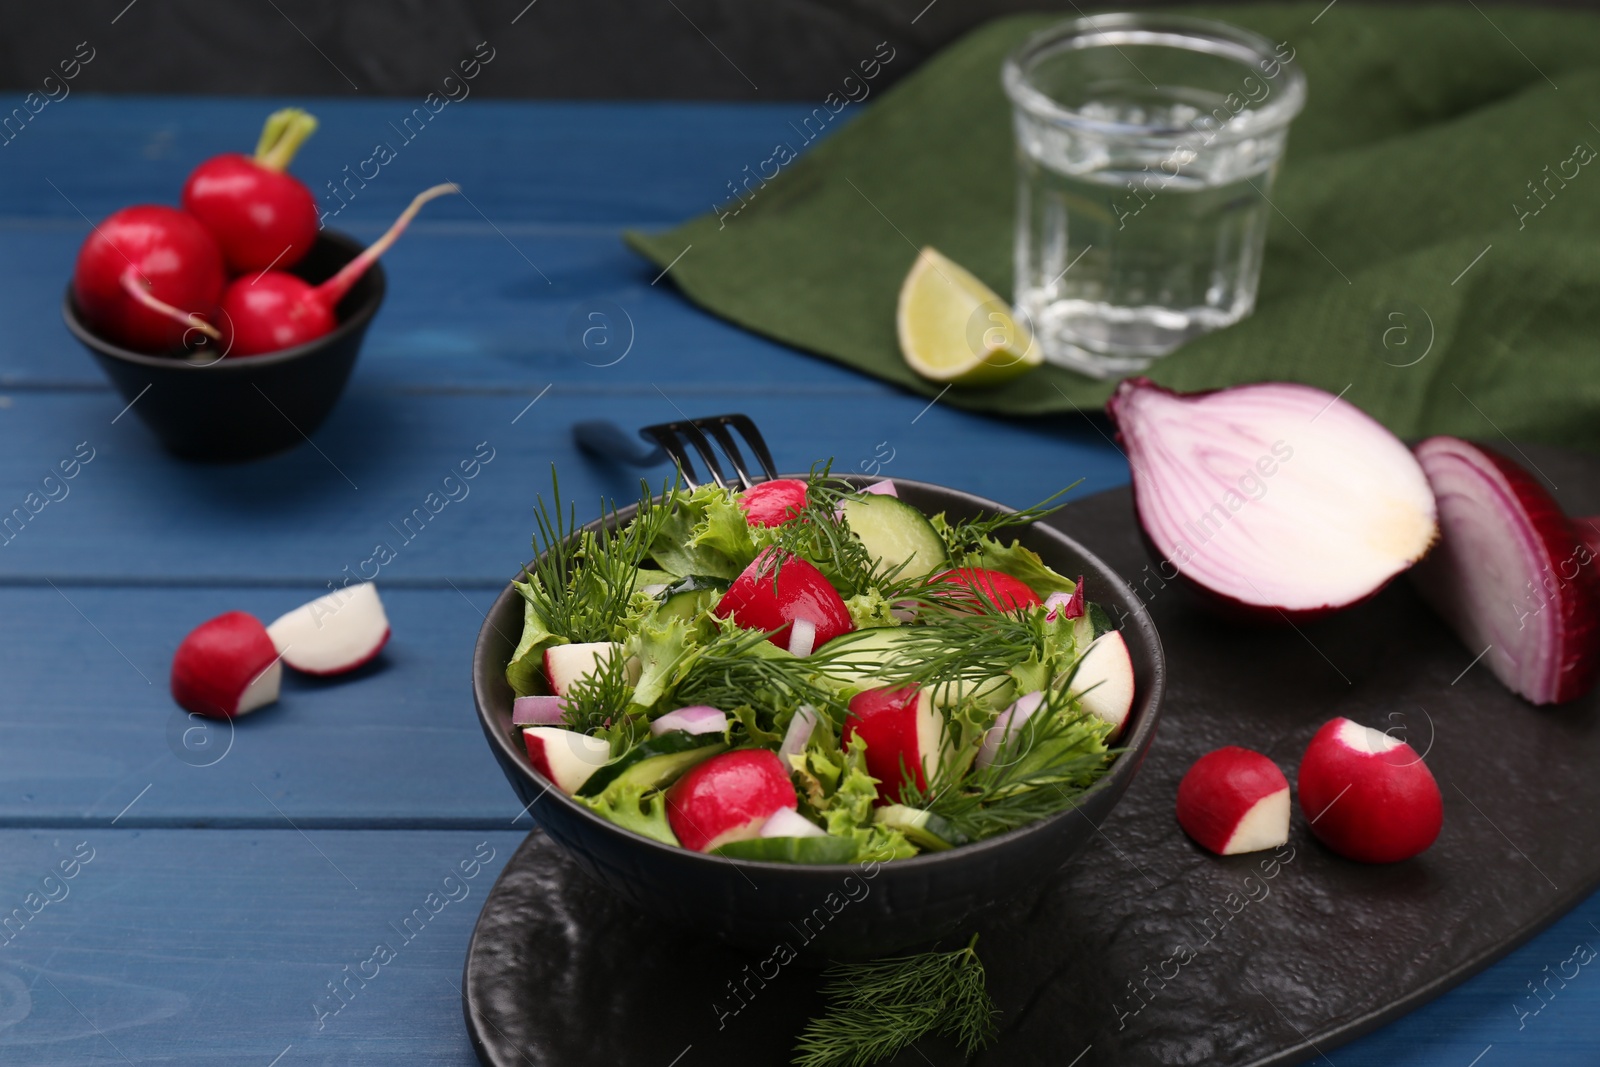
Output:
[1298, 718, 1445, 864]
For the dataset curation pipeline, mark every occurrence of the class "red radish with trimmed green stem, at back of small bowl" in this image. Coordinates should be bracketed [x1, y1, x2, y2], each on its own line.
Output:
[184, 107, 317, 274]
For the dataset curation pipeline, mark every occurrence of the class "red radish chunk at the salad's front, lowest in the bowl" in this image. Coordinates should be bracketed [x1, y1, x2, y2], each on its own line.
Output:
[667, 749, 800, 853]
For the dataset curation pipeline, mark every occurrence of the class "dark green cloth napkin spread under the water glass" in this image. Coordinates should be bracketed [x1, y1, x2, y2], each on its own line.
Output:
[627, 2, 1600, 448]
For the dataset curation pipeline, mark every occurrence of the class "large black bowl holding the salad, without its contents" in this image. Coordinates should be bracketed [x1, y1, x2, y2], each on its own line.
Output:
[472, 475, 1166, 961]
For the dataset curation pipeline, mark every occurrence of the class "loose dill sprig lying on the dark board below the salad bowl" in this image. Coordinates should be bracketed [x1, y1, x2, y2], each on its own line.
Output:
[792, 934, 1000, 1067]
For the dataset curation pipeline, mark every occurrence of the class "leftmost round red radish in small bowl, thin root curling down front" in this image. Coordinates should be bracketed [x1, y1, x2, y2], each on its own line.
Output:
[72, 205, 226, 352]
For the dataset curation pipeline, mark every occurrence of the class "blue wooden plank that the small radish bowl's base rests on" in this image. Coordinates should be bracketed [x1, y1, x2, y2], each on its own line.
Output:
[0, 390, 1126, 585]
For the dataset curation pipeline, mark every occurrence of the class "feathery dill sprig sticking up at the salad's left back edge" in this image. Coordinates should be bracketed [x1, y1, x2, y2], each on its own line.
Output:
[518, 467, 675, 641]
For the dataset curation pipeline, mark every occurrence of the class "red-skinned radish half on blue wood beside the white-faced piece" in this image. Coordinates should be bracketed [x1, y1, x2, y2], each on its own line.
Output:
[171, 611, 283, 718]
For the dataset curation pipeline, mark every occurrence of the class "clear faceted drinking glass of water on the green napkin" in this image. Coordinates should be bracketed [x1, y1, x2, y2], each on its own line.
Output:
[1002, 14, 1306, 378]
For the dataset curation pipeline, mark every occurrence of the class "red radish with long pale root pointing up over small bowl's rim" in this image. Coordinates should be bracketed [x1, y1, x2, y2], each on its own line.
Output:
[221, 182, 458, 355]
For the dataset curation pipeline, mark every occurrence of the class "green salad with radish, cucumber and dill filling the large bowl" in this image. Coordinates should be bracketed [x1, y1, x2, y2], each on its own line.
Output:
[502, 470, 1144, 865]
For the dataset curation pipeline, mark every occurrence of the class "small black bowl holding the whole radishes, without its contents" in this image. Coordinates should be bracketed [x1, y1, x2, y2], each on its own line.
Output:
[61, 230, 384, 461]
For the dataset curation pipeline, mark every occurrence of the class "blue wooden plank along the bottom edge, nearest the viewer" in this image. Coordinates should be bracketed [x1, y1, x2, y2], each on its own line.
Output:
[0, 827, 1600, 1067]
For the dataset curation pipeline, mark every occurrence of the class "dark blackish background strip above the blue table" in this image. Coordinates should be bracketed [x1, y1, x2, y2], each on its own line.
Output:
[0, 0, 1600, 101]
